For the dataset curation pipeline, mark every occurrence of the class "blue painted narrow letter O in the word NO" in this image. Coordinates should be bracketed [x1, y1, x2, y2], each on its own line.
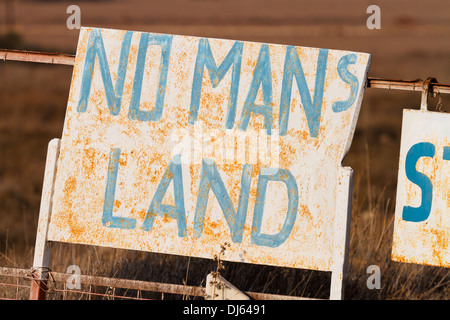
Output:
[128, 33, 172, 121]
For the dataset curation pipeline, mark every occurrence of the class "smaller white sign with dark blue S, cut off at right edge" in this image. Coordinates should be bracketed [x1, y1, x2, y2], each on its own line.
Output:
[392, 110, 450, 267]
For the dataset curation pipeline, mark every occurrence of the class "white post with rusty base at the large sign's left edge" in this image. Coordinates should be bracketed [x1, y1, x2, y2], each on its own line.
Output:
[30, 139, 61, 300]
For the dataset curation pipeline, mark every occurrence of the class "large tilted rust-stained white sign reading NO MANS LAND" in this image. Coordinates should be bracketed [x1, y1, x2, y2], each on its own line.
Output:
[48, 28, 370, 270]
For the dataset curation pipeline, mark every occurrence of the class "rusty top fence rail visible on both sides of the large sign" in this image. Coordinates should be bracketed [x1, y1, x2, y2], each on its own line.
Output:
[0, 49, 450, 94]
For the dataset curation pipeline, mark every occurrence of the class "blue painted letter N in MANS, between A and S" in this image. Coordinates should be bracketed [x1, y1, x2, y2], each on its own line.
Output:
[279, 46, 328, 138]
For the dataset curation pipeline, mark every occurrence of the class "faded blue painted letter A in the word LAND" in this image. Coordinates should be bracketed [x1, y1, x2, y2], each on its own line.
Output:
[142, 155, 187, 237]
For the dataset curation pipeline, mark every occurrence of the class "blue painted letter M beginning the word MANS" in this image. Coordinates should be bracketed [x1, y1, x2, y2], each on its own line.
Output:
[189, 38, 244, 129]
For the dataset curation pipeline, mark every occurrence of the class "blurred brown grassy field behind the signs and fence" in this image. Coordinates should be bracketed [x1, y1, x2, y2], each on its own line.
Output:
[0, 0, 450, 299]
